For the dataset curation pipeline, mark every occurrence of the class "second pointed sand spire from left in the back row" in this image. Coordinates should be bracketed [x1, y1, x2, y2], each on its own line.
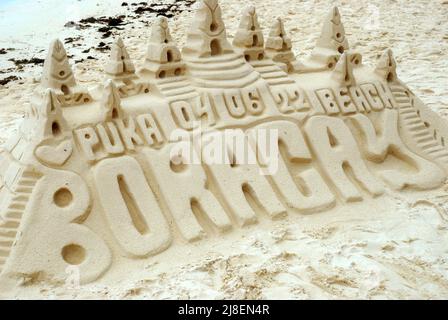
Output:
[104, 38, 136, 80]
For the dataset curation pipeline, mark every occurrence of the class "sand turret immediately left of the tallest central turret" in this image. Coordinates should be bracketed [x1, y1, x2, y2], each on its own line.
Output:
[141, 17, 185, 79]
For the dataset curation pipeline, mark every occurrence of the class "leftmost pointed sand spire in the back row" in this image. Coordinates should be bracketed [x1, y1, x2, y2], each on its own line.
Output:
[41, 39, 76, 94]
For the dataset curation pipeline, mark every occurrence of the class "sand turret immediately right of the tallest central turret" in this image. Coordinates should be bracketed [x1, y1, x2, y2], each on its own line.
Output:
[233, 6, 264, 61]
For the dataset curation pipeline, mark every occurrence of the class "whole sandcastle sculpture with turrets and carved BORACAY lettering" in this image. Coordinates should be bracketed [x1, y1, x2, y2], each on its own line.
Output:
[0, 0, 448, 285]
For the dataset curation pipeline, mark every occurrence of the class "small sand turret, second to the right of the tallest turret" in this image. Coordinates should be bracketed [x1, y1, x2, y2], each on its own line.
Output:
[266, 18, 295, 72]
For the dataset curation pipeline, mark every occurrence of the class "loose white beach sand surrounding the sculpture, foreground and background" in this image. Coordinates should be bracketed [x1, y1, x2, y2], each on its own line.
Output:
[0, 0, 448, 299]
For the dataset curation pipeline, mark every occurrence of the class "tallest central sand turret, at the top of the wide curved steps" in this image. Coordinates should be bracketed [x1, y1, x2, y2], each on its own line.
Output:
[182, 0, 233, 58]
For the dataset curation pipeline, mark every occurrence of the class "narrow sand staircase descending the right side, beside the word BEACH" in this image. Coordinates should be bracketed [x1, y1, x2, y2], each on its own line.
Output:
[390, 85, 448, 165]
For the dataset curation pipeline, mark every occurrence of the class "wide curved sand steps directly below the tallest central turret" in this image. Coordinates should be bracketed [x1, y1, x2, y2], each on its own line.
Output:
[188, 53, 260, 89]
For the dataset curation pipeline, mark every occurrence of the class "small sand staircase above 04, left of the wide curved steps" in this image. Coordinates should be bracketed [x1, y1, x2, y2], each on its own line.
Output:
[155, 76, 198, 101]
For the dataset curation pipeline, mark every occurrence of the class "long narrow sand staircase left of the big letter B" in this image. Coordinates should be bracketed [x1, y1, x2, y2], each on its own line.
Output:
[0, 169, 39, 273]
